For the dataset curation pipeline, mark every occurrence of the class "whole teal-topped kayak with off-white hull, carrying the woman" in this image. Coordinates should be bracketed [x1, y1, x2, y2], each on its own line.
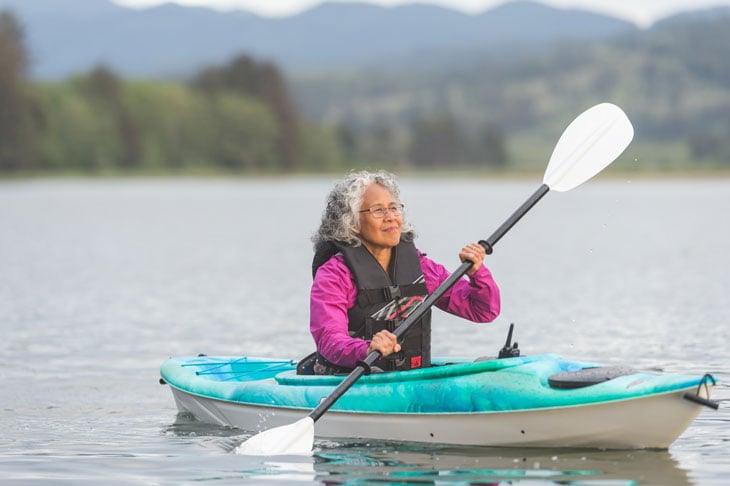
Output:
[160, 354, 717, 449]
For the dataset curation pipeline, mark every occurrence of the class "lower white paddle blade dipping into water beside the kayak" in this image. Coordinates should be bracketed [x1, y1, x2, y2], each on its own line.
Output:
[235, 417, 314, 456]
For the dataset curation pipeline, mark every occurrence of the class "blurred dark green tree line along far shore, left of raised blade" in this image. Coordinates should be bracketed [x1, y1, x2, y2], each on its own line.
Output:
[0, 11, 508, 174]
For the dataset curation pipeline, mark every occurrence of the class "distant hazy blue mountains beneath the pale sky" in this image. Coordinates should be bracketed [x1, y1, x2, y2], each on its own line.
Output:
[0, 0, 636, 80]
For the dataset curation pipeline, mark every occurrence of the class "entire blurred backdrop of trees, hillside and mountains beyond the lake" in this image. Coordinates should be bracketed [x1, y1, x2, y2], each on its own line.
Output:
[0, 0, 730, 176]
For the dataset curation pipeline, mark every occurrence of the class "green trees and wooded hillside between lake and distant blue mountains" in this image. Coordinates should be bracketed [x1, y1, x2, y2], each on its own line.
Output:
[0, 12, 730, 176]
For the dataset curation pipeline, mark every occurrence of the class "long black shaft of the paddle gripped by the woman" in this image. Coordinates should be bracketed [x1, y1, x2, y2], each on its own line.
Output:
[309, 184, 550, 422]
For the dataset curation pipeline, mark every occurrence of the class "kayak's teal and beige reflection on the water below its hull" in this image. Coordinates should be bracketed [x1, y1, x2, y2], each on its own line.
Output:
[314, 444, 688, 485]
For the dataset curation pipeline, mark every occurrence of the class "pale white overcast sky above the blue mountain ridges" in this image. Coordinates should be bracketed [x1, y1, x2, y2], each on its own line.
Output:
[113, 0, 730, 26]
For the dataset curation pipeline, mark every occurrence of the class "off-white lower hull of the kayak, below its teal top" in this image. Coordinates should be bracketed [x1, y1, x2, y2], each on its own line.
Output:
[172, 387, 711, 449]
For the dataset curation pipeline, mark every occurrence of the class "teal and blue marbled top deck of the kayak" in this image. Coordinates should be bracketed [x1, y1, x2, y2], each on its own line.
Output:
[161, 354, 712, 414]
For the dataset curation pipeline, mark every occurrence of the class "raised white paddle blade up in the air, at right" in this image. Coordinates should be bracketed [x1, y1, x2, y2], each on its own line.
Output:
[543, 103, 634, 192]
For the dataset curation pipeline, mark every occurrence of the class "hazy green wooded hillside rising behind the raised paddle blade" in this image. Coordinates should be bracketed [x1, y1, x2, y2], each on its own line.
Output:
[292, 9, 730, 167]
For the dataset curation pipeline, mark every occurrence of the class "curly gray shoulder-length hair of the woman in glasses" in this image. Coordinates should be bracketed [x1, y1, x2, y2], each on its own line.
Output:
[312, 171, 416, 251]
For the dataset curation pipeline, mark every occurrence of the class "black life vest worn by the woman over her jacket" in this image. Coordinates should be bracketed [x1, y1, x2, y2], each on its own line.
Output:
[312, 241, 431, 371]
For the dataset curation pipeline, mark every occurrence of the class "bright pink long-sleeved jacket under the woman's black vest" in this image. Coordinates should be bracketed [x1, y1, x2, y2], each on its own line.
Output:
[309, 251, 500, 368]
